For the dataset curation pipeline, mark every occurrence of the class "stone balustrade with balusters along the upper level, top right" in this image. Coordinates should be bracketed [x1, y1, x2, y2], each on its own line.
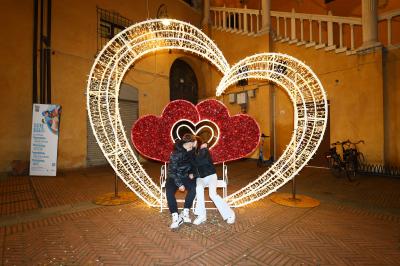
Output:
[210, 6, 400, 54]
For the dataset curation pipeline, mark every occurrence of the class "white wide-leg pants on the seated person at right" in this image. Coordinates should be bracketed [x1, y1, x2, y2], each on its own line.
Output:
[195, 174, 234, 220]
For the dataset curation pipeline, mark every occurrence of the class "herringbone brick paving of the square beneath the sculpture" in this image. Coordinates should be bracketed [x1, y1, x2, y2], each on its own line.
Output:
[0, 161, 400, 265]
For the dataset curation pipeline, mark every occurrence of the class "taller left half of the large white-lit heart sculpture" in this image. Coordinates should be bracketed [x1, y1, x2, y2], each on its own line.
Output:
[87, 20, 229, 206]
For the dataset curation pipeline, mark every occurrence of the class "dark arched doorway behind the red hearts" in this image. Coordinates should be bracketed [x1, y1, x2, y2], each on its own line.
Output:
[169, 59, 198, 104]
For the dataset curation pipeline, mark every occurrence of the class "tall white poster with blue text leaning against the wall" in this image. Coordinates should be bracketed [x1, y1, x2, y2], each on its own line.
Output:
[29, 104, 61, 176]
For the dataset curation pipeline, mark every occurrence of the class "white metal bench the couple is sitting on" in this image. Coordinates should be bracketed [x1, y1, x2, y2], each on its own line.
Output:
[160, 163, 228, 212]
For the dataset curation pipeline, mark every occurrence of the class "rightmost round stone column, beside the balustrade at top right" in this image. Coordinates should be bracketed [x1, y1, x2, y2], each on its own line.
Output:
[360, 0, 381, 49]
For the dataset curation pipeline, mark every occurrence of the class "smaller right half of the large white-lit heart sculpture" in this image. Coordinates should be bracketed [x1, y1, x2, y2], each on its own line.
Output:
[217, 53, 327, 207]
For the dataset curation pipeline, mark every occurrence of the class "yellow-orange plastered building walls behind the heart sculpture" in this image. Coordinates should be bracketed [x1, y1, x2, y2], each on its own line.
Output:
[0, 0, 400, 172]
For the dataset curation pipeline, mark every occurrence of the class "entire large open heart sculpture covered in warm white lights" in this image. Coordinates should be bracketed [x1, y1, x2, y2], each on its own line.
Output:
[87, 19, 328, 207]
